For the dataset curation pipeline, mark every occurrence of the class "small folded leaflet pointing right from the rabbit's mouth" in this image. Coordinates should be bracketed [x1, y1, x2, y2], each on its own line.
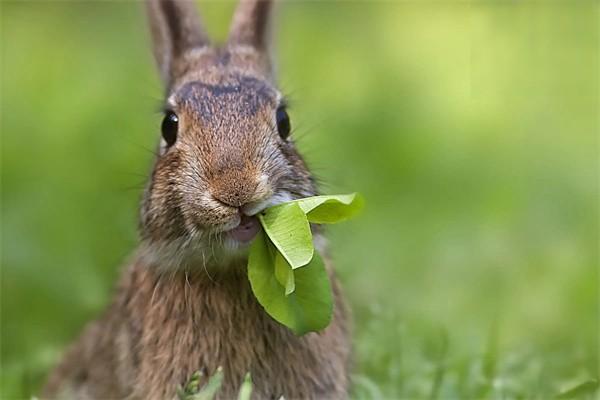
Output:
[288, 193, 364, 224]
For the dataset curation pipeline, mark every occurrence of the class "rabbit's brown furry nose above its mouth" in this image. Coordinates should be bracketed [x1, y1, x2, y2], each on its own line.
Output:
[211, 170, 258, 208]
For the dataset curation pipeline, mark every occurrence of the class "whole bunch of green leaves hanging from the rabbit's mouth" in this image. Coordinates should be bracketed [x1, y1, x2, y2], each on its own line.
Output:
[248, 193, 363, 335]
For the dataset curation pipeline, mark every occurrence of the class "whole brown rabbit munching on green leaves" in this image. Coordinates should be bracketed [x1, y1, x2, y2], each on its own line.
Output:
[42, 0, 351, 399]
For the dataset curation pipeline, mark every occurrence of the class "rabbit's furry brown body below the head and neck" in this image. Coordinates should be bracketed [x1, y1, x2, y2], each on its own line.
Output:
[43, 258, 349, 399]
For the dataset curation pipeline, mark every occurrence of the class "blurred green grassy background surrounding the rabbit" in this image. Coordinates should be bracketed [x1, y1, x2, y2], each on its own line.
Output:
[0, 1, 600, 399]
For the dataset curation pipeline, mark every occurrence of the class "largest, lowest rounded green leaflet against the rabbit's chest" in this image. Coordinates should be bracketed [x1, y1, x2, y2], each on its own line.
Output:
[248, 232, 333, 335]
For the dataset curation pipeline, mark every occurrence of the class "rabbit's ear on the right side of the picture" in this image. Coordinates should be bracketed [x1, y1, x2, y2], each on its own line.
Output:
[229, 0, 273, 55]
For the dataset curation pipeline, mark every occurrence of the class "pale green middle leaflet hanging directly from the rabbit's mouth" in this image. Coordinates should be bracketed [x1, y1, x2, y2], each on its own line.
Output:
[258, 202, 314, 269]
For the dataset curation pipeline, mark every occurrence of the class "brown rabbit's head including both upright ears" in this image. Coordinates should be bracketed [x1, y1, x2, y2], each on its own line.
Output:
[140, 0, 315, 268]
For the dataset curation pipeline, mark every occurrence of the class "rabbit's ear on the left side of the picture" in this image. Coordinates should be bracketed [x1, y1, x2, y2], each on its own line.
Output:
[146, 0, 209, 87]
